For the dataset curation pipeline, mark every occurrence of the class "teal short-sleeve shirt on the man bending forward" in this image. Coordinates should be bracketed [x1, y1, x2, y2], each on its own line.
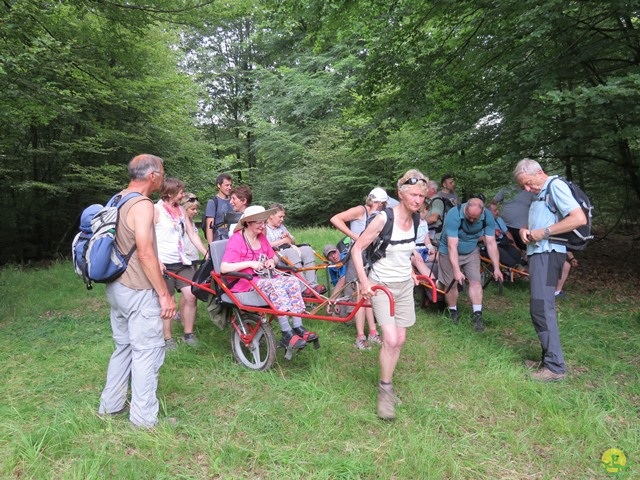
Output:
[439, 203, 496, 255]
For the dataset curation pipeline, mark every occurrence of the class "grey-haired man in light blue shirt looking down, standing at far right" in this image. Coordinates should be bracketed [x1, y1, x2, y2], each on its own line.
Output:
[513, 158, 587, 382]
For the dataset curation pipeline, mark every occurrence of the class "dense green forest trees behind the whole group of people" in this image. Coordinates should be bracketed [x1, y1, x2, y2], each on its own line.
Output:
[0, 0, 640, 264]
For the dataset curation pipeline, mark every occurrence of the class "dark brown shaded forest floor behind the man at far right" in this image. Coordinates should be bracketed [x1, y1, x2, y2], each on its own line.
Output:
[567, 234, 640, 300]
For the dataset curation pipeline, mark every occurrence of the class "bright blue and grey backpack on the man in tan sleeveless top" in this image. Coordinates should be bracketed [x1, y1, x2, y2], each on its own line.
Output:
[71, 192, 141, 290]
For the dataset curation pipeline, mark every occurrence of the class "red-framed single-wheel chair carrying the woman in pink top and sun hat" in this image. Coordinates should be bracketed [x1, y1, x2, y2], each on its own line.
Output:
[166, 240, 395, 370]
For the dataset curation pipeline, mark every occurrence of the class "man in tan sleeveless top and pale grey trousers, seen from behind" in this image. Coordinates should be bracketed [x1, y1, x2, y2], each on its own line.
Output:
[98, 154, 176, 428]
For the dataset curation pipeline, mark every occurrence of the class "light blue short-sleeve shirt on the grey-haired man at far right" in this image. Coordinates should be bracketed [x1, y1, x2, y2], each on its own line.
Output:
[527, 177, 580, 255]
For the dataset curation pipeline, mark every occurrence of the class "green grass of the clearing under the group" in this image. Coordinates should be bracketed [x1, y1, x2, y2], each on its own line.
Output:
[0, 229, 640, 479]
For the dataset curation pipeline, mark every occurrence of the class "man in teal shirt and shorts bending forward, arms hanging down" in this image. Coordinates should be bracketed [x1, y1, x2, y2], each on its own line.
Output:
[438, 194, 503, 332]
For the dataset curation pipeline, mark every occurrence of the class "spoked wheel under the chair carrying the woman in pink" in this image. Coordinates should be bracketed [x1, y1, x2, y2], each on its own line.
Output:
[231, 309, 276, 370]
